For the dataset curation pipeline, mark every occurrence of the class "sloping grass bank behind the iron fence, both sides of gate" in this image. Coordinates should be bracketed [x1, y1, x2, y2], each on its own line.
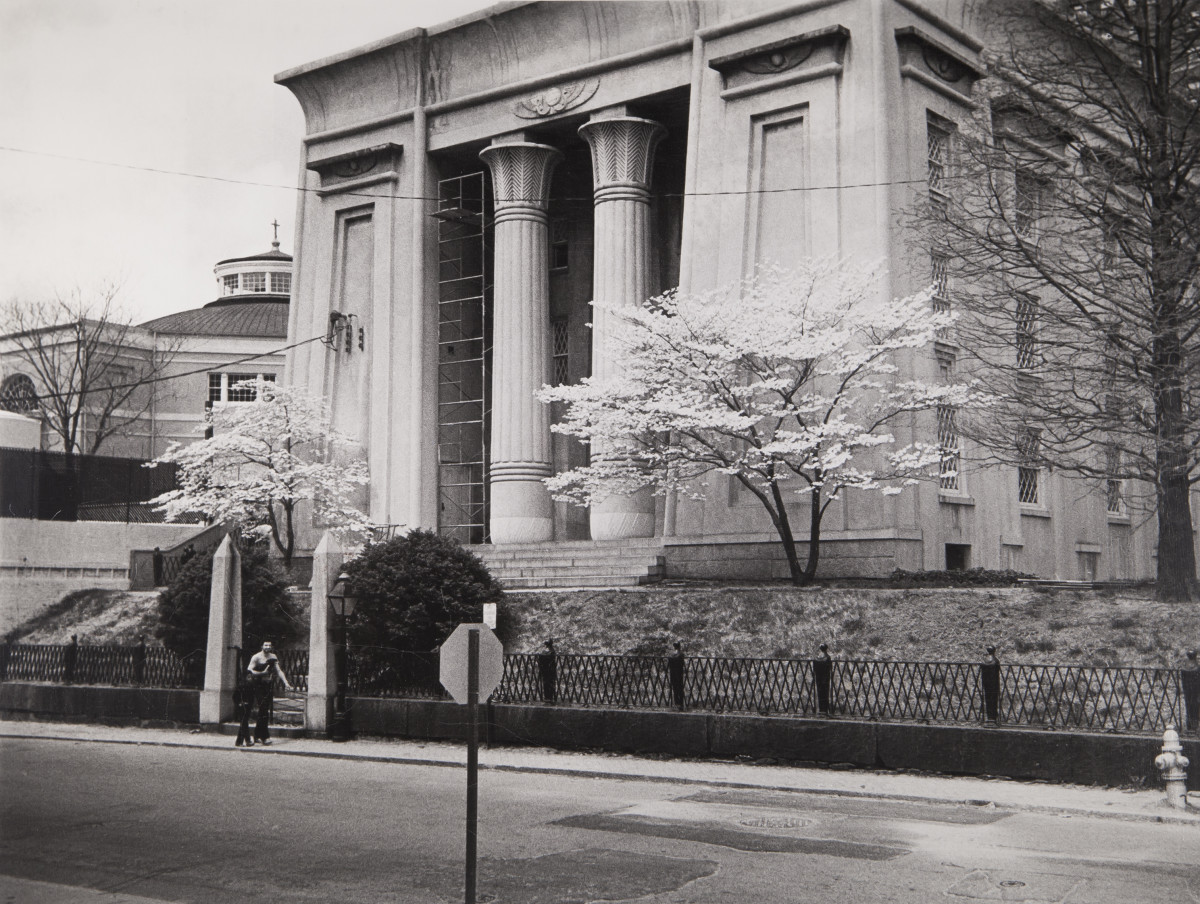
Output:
[14, 585, 1200, 666]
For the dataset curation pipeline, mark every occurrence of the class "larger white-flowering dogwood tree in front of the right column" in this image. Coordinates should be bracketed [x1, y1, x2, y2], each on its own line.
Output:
[539, 261, 983, 585]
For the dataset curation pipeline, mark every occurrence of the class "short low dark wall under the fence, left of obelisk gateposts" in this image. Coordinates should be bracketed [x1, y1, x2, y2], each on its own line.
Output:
[0, 682, 200, 725]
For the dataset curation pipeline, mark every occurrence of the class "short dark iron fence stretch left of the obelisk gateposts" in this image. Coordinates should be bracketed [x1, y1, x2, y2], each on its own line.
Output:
[0, 642, 204, 688]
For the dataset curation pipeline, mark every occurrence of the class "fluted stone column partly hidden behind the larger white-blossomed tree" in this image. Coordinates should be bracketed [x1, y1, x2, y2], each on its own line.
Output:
[580, 114, 666, 540]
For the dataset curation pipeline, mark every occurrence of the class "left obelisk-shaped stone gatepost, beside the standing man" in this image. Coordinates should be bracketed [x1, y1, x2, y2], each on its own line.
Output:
[200, 534, 241, 725]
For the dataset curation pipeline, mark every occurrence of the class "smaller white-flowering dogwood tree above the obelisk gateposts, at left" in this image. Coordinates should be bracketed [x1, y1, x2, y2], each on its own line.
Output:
[154, 379, 373, 567]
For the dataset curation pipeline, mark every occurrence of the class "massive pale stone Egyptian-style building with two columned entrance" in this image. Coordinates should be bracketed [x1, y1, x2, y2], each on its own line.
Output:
[276, 0, 1154, 585]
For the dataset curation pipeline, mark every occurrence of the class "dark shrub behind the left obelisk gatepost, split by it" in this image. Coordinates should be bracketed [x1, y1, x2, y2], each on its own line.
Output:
[156, 537, 296, 657]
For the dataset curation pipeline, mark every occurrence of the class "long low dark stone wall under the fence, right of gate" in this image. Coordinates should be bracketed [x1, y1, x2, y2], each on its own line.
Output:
[350, 698, 1200, 790]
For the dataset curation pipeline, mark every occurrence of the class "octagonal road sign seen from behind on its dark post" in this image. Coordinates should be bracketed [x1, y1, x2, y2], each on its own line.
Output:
[438, 624, 504, 904]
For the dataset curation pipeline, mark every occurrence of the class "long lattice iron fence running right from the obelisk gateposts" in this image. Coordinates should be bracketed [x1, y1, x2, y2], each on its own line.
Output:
[349, 649, 1198, 731]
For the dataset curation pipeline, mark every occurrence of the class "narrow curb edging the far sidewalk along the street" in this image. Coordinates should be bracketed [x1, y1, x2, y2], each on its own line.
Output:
[9, 731, 1200, 826]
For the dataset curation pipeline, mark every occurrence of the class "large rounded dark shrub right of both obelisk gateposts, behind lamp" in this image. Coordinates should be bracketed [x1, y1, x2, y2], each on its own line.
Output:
[344, 529, 505, 651]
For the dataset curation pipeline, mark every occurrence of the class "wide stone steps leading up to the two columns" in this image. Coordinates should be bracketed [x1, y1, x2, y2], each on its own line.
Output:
[469, 538, 665, 589]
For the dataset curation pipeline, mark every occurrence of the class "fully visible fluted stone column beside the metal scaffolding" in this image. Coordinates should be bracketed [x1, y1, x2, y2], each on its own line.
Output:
[479, 139, 562, 544]
